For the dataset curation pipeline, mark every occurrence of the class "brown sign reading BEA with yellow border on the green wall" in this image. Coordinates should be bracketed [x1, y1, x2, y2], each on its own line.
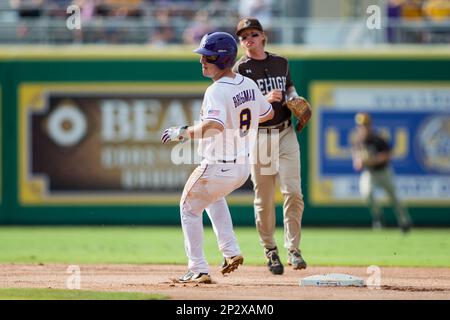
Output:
[19, 82, 262, 205]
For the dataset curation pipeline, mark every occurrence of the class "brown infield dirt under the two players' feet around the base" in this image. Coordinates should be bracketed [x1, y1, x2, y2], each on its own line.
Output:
[0, 264, 450, 300]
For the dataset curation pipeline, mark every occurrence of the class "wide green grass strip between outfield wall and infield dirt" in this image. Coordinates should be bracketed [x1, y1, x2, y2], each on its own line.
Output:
[0, 227, 450, 267]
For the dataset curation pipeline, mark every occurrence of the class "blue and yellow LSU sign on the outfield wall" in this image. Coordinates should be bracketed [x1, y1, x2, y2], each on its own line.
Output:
[309, 82, 450, 205]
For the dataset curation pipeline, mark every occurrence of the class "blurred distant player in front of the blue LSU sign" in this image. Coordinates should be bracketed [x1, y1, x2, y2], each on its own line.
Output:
[352, 112, 411, 233]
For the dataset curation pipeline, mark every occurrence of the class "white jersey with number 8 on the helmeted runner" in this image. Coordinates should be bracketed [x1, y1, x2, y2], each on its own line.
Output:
[198, 74, 272, 163]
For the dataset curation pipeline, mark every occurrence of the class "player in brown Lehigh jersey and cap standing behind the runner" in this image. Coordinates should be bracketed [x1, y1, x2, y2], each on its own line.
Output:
[233, 18, 306, 274]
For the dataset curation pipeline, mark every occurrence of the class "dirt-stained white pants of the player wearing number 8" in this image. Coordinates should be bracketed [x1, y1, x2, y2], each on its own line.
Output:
[180, 163, 250, 273]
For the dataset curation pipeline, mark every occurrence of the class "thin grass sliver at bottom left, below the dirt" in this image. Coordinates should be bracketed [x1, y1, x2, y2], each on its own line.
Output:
[0, 288, 166, 300]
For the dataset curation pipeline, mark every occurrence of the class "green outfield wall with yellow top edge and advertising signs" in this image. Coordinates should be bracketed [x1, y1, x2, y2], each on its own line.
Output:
[0, 47, 450, 226]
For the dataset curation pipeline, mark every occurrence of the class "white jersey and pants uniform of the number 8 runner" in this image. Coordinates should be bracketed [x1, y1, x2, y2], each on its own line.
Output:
[180, 74, 272, 273]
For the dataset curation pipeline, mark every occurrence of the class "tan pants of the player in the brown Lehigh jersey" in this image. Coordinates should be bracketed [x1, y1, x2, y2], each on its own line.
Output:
[251, 126, 304, 249]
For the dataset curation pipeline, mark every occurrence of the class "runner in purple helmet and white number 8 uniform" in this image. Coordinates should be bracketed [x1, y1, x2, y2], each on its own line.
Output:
[161, 32, 273, 283]
